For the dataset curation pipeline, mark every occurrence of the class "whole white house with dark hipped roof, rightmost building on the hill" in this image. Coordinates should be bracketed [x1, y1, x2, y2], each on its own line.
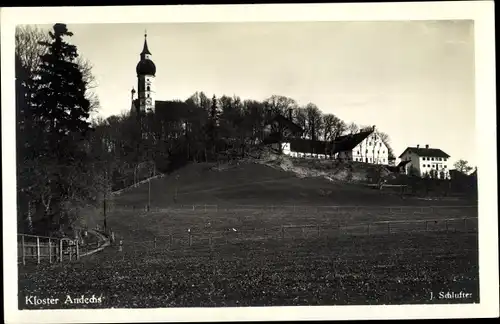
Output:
[399, 145, 450, 179]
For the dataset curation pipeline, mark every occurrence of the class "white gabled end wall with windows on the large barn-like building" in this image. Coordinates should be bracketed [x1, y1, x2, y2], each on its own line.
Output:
[346, 132, 389, 165]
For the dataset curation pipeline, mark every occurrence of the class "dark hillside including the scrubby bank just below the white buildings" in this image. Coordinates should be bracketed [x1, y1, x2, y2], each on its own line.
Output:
[113, 157, 476, 209]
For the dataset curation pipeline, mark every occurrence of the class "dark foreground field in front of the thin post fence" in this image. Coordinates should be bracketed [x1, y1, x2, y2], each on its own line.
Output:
[19, 232, 479, 309]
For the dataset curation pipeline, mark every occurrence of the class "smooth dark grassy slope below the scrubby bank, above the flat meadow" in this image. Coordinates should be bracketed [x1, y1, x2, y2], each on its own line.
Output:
[110, 163, 476, 208]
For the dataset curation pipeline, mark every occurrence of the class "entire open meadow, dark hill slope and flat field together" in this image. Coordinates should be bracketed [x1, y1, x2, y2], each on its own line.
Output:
[19, 164, 479, 308]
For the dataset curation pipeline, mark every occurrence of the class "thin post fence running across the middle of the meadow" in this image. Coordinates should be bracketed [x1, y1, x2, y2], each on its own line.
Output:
[118, 217, 478, 252]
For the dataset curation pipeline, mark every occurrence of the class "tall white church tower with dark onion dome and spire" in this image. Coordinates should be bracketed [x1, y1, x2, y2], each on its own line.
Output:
[135, 34, 156, 113]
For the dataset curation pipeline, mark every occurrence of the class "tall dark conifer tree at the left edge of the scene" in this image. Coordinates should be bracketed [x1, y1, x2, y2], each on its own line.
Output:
[27, 24, 92, 232]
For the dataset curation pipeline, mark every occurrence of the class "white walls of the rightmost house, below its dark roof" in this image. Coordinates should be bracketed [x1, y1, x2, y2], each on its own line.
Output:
[401, 148, 450, 179]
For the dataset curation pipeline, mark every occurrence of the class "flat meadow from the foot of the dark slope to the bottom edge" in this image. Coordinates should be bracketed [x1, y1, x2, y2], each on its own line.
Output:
[19, 207, 479, 308]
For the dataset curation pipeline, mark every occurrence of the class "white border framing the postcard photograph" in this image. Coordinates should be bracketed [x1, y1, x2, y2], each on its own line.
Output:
[0, 1, 499, 323]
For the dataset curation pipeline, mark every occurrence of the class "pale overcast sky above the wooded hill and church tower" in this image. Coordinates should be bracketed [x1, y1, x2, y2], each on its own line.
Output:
[36, 20, 476, 165]
